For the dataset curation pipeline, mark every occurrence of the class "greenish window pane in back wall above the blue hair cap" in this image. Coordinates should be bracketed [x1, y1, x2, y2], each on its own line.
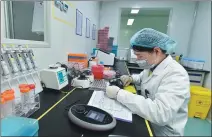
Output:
[118, 16, 169, 48]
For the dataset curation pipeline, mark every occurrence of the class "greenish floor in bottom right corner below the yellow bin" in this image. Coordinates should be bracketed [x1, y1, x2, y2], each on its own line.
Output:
[184, 118, 211, 136]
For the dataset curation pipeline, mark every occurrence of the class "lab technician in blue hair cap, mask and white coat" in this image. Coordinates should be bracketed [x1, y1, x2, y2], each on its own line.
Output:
[106, 28, 190, 136]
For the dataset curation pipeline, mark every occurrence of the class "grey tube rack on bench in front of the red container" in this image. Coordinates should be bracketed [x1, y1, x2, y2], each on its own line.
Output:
[89, 79, 109, 91]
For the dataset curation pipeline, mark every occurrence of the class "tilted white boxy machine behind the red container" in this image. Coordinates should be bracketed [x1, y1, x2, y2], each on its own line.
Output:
[96, 49, 115, 66]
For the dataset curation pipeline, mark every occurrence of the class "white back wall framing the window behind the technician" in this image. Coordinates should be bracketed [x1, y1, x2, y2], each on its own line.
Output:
[100, 1, 195, 55]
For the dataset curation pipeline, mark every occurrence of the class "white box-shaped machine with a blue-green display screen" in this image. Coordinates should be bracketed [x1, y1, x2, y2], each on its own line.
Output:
[40, 67, 68, 90]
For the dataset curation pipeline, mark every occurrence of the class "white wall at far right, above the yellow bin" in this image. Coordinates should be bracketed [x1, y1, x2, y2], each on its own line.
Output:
[188, 1, 211, 89]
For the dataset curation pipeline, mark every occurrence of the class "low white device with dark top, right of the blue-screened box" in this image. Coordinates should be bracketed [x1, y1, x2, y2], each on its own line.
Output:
[72, 74, 90, 88]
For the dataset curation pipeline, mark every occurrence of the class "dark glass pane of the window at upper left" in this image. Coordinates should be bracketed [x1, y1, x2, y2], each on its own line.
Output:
[7, 1, 44, 41]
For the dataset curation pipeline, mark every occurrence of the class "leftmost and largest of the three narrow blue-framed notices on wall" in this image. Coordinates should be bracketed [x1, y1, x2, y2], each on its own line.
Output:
[76, 9, 83, 36]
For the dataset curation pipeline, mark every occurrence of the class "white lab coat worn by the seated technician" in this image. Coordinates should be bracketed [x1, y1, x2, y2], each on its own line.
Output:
[117, 55, 190, 136]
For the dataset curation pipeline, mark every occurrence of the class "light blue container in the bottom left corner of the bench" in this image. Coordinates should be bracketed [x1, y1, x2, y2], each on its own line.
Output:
[1, 116, 39, 137]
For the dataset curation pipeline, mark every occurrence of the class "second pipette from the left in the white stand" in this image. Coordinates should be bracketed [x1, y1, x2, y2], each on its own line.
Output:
[6, 51, 19, 75]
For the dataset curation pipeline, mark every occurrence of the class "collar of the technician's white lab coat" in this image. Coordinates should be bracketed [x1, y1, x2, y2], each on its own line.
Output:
[152, 55, 173, 75]
